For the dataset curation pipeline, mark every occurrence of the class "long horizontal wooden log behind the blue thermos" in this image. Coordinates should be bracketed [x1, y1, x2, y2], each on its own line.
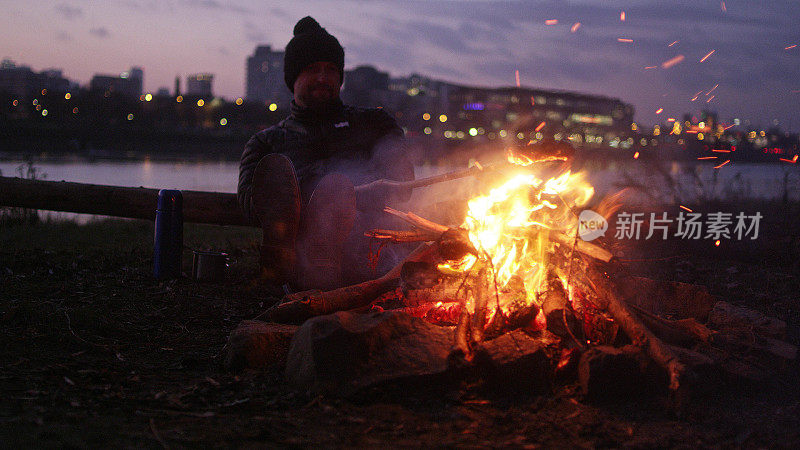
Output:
[0, 177, 258, 227]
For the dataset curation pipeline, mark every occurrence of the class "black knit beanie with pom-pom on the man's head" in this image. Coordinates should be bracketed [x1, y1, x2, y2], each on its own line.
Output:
[283, 16, 344, 92]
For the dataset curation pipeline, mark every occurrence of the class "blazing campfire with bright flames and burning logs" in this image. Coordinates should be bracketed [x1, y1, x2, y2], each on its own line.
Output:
[231, 145, 796, 404]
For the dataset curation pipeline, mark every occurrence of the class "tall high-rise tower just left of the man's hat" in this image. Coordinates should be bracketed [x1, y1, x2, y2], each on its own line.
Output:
[245, 45, 292, 106]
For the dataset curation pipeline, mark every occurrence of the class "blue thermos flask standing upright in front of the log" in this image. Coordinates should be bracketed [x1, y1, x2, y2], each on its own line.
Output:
[153, 189, 183, 280]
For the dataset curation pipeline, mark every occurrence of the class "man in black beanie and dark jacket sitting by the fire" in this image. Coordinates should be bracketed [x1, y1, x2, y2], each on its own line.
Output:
[238, 17, 414, 290]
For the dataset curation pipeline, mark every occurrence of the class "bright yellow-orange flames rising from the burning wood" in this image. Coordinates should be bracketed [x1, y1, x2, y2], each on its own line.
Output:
[440, 159, 594, 310]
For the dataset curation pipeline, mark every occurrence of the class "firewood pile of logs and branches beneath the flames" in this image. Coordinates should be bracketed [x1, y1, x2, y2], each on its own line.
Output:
[223, 151, 797, 405]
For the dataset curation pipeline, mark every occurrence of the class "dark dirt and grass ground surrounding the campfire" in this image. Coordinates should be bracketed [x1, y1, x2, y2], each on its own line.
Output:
[0, 220, 800, 448]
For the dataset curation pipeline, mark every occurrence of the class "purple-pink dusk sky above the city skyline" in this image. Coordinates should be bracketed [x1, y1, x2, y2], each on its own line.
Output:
[6, 0, 800, 131]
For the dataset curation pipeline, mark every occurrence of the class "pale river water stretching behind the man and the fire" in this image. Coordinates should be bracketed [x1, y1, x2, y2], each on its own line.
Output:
[0, 159, 800, 221]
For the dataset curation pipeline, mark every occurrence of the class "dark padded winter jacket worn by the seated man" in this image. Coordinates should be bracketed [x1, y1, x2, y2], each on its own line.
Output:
[238, 101, 413, 221]
